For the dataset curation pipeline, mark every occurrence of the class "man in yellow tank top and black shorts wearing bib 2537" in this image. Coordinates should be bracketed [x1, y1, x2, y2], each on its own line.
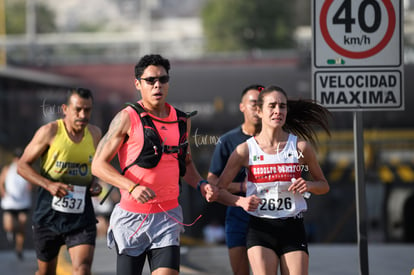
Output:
[18, 88, 101, 275]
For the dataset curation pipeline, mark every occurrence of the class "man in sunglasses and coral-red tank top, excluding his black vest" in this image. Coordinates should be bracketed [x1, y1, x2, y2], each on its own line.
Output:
[92, 55, 215, 275]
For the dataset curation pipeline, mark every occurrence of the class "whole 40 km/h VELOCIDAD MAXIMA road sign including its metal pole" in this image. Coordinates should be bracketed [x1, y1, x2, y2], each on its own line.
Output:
[312, 0, 404, 274]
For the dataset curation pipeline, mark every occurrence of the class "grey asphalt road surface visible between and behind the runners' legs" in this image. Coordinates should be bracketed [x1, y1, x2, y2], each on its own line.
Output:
[0, 239, 414, 275]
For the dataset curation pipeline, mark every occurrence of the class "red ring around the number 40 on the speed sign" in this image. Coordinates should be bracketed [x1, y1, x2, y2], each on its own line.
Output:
[319, 0, 395, 59]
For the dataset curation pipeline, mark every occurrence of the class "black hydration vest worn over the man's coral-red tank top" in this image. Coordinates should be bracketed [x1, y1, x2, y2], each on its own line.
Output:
[122, 103, 197, 177]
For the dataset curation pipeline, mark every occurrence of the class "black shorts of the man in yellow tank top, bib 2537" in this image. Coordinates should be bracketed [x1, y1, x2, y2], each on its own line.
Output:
[33, 224, 96, 262]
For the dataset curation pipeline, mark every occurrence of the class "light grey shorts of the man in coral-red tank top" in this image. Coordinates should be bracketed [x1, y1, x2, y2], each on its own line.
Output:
[107, 204, 184, 256]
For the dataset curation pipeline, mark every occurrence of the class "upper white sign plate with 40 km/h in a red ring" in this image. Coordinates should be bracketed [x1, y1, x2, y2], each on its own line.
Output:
[313, 0, 403, 67]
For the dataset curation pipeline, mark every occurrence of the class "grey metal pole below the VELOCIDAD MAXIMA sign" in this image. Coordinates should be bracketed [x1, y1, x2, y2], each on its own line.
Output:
[354, 111, 369, 275]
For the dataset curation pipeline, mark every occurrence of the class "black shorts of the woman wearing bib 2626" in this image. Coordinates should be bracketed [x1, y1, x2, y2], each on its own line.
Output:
[247, 216, 309, 258]
